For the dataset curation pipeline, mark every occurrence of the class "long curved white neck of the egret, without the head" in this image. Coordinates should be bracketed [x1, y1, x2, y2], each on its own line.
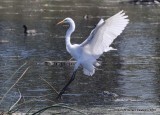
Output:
[66, 20, 75, 47]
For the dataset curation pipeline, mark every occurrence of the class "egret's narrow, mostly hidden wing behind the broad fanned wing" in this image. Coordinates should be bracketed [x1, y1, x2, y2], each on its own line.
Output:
[80, 18, 104, 46]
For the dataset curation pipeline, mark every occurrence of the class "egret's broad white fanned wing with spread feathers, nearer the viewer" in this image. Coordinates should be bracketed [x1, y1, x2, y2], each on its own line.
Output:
[83, 11, 129, 59]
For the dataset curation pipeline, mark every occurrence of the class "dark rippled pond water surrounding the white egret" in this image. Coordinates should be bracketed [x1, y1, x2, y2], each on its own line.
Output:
[0, 0, 160, 111]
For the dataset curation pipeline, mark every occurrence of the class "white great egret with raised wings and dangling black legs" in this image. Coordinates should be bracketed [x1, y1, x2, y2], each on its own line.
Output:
[57, 10, 129, 98]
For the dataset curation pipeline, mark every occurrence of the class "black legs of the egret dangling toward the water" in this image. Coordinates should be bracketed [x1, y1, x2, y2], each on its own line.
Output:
[57, 70, 77, 99]
